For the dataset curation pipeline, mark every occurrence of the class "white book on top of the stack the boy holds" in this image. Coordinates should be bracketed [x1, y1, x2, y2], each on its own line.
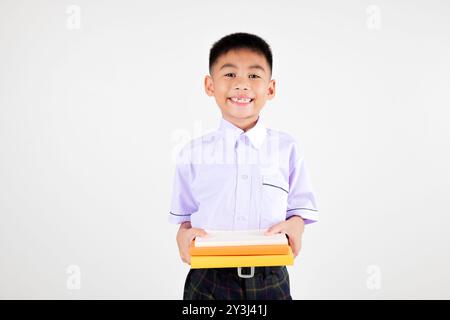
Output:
[195, 230, 288, 247]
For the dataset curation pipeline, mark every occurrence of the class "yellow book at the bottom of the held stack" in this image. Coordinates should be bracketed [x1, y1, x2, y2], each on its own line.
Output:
[191, 247, 294, 269]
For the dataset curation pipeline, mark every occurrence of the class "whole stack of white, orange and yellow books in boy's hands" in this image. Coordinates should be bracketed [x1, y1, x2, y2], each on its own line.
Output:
[189, 230, 294, 269]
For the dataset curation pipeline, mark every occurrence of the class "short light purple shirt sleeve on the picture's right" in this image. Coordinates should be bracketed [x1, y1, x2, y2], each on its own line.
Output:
[286, 142, 319, 224]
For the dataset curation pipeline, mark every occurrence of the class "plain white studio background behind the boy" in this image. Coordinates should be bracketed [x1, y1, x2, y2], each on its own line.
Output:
[0, 0, 450, 299]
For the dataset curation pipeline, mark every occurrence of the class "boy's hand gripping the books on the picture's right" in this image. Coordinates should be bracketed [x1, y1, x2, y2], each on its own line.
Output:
[266, 216, 305, 257]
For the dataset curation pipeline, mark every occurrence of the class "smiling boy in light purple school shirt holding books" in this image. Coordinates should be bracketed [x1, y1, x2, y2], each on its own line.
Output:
[169, 33, 318, 300]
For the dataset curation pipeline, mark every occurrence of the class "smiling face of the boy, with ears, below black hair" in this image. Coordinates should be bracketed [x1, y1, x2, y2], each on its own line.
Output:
[205, 49, 275, 126]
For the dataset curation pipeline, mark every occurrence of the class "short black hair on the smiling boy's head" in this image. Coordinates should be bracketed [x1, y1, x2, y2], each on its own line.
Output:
[209, 32, 272, 74]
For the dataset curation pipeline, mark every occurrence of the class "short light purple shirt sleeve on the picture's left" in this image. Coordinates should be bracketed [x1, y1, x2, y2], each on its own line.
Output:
[169, 149, 198, 224]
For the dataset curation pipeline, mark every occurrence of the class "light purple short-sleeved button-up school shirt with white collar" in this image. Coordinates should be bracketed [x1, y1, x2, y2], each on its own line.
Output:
[169, 117, 319, 230]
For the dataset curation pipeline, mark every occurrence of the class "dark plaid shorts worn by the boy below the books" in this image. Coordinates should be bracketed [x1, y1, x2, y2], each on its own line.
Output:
[183, 266, 292, 300]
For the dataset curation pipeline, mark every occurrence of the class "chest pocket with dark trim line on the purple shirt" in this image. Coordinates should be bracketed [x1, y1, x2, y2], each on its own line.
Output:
[260, 174, 289, 228]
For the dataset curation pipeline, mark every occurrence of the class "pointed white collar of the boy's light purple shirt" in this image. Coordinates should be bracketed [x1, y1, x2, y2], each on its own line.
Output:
[219, 115, 267, 149]
